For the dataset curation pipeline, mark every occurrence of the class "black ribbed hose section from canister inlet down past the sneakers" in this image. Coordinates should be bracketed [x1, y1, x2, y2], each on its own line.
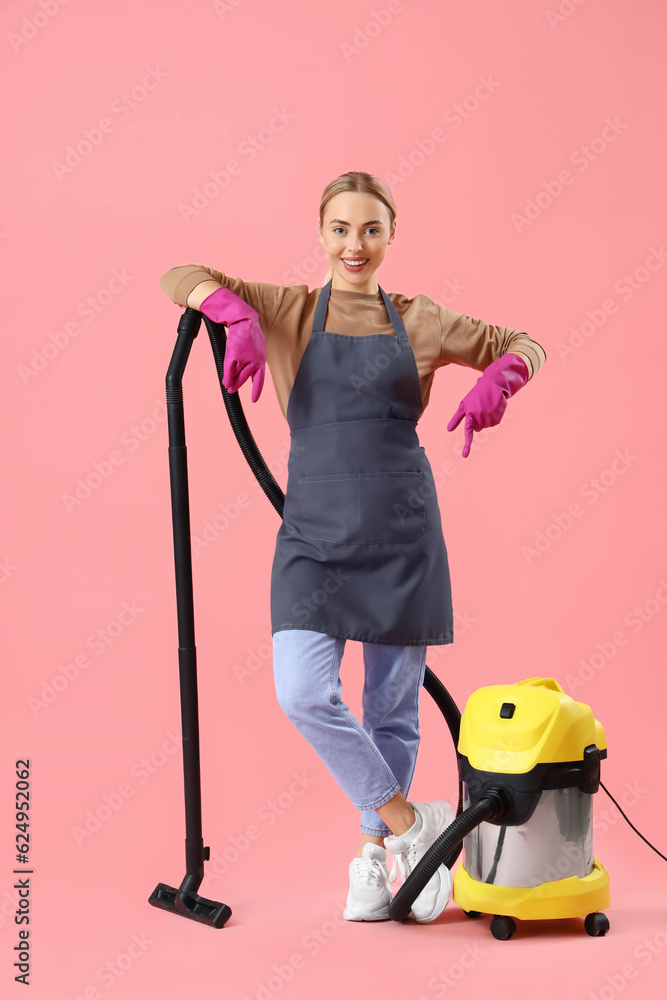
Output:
[389, 788, 506, 920]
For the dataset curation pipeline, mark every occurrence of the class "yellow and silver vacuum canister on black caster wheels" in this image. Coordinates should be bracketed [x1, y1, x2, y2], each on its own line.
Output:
[454, 677, 610, 938]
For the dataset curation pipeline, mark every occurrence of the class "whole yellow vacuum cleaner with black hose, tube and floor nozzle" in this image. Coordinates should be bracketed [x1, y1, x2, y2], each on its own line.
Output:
[149, 307, 644, 940]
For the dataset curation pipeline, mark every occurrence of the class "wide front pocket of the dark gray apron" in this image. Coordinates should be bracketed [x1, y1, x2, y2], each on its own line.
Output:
[299, 472, 426, 545]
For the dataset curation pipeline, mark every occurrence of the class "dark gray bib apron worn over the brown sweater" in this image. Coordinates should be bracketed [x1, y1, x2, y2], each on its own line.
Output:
[271, 281, 454, 646]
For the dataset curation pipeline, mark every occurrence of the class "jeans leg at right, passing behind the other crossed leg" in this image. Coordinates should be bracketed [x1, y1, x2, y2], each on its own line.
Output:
[361, 643, 427, 837]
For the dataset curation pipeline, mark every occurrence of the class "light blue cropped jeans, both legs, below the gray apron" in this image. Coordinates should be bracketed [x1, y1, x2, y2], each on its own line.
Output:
[273, 629, 427, 837]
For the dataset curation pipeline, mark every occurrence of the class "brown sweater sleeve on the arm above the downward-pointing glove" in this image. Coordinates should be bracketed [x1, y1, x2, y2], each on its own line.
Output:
[438, 306, 547, 378]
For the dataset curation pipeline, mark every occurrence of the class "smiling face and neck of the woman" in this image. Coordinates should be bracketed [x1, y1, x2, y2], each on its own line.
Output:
[320, 191, 396, 292]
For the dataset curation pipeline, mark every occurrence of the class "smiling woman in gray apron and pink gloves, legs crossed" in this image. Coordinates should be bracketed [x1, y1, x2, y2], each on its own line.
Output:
[160, 171, 546, 923]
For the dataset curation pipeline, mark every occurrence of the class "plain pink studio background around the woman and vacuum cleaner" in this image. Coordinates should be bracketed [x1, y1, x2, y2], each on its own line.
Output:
[0, 0, 667, 1000]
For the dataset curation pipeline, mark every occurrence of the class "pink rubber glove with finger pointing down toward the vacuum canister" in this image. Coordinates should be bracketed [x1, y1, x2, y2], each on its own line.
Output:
[447, 354, 528, 458]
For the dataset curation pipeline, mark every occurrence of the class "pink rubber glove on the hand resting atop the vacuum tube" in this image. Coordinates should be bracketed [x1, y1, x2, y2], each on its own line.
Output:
[199, 288, 266, 403]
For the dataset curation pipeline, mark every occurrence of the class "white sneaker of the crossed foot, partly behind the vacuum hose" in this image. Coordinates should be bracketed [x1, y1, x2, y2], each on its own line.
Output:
[384, 802, 454, 924]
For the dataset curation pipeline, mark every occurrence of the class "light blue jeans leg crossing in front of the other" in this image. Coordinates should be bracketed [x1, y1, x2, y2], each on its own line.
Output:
[273, 629, 399, 812]
